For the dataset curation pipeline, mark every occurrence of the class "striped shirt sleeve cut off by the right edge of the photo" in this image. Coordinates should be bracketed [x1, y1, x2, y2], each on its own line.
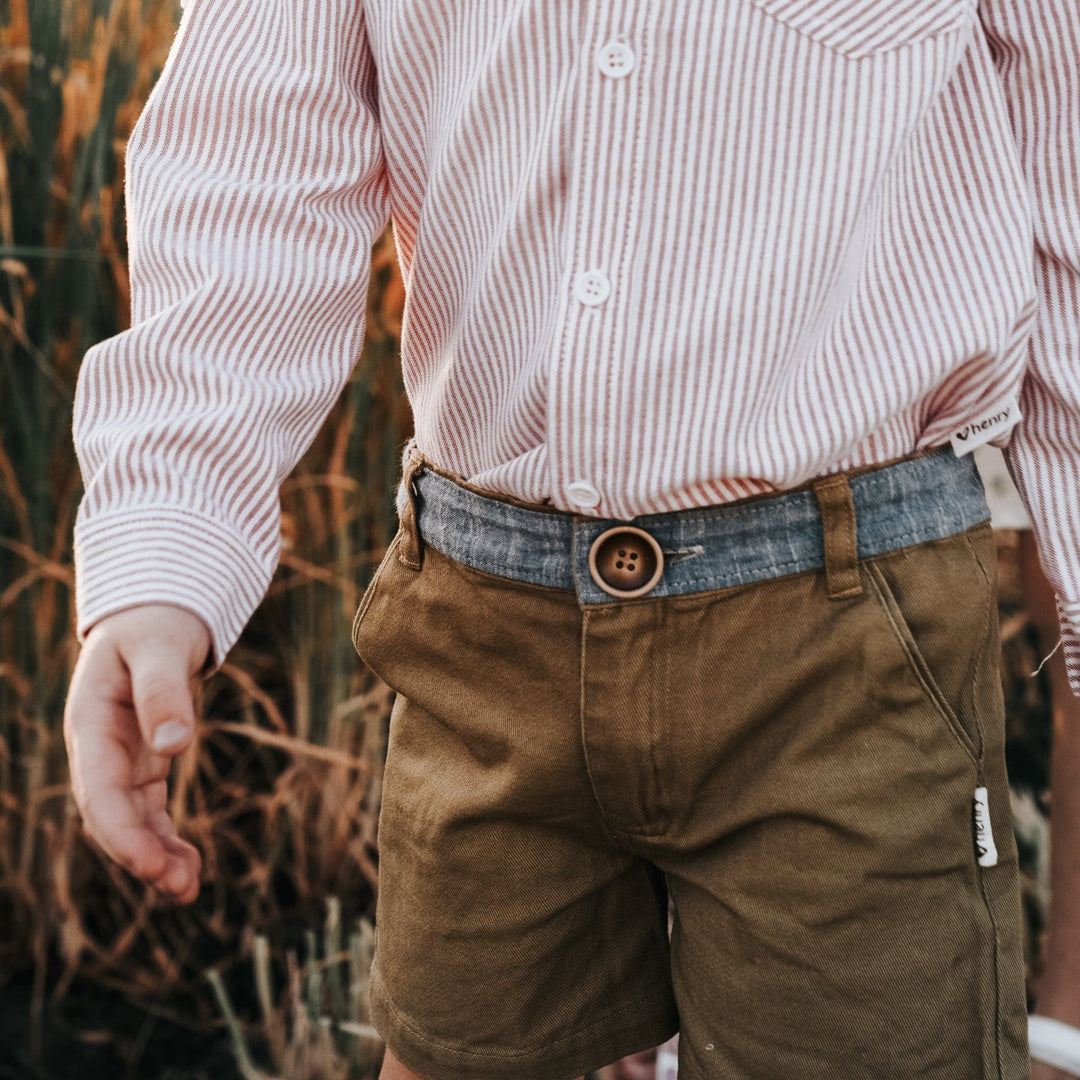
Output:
[980, 0, 1080, 694]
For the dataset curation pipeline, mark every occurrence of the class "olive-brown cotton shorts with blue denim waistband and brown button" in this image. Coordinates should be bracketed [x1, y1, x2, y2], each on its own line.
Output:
[352, 442, 1029, 1080]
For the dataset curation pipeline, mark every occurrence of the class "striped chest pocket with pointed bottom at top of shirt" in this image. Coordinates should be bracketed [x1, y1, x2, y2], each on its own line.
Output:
[750, 0, 976, 59]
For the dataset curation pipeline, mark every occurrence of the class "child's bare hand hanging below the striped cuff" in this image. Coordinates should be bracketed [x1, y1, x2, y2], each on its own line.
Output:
[64, 604, 211, 904]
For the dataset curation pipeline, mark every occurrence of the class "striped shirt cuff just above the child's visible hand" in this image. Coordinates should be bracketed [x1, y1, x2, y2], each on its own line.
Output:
[73, 507, 273, 678]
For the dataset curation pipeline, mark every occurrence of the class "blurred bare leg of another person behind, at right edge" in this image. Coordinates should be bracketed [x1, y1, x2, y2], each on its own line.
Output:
[1020, 531, 1080, 1080]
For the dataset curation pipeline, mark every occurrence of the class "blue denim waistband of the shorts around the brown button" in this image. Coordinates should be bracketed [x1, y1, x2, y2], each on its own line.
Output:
[399, 448, 990, 604]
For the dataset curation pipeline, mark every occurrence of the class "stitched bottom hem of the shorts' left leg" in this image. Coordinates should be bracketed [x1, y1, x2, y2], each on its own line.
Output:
[370, 967, 678, 1080]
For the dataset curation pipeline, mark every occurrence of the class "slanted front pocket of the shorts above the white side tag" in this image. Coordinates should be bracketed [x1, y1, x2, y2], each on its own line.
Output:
[863, 525, 996, 766]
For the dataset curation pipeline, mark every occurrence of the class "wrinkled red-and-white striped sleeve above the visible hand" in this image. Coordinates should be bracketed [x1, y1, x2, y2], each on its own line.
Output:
[72, 0, 390, 674]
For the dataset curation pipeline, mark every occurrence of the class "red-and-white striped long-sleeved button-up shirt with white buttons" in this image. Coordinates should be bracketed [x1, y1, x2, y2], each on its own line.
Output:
[73, 0, 1080, 690]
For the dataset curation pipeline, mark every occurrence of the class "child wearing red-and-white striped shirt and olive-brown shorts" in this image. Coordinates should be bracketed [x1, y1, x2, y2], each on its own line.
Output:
[65, 0, 1080, 1080]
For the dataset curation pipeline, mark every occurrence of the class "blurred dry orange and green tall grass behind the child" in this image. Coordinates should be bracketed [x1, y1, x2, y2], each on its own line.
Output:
[0, 0, 1049, 1080]
